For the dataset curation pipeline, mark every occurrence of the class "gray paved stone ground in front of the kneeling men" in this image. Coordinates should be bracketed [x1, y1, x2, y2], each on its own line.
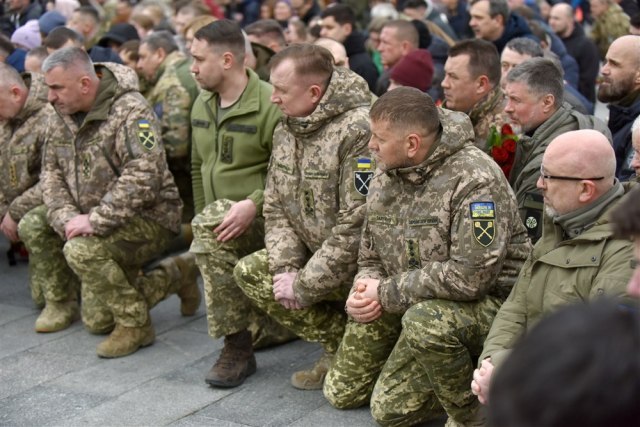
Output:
[0, 239, 443, 427]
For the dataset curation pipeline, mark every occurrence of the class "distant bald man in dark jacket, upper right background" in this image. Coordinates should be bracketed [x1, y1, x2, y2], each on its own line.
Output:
[549, 3, 600, 103]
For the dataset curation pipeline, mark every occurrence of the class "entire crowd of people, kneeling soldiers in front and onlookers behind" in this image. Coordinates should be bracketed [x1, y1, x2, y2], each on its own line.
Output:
[0, 0, 640, 427]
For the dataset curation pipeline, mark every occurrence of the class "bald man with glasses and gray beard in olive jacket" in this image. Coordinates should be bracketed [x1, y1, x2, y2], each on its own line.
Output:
[471, 130, 633, 403]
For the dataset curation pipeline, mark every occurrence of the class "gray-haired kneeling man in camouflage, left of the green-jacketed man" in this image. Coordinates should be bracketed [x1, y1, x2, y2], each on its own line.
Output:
[18, 47, 182, 358]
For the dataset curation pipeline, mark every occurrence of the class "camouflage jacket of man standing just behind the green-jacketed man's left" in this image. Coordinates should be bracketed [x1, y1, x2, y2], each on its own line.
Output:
[146, 52, 198, 163]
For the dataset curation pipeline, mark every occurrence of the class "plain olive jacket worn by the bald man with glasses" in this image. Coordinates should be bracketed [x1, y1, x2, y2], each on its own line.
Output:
[479, 189, 633, 365]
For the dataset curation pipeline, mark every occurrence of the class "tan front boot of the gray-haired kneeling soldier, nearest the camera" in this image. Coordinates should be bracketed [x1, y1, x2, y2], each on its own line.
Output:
[96, 319, 156, 359]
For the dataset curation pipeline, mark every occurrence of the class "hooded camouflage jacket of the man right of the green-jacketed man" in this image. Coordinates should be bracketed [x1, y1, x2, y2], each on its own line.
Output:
[264, 68, 373, 305]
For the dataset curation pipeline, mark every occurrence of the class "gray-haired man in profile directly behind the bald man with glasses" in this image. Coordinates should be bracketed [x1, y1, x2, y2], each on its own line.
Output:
[504, 58, 611, 242]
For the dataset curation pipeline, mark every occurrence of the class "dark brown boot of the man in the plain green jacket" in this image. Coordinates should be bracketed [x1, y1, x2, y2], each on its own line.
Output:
[205, 329, 256, 388]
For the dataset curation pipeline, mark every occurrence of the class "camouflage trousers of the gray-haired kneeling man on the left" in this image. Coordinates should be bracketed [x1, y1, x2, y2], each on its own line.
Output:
[20, 207, 179, 333]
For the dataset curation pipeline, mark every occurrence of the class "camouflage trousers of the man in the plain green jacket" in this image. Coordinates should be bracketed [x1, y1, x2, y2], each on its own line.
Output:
[191, 200, 297, 348]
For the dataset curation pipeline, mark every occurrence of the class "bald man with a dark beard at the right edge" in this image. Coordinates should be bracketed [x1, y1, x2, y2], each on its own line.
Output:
[598, 36, 640, 181]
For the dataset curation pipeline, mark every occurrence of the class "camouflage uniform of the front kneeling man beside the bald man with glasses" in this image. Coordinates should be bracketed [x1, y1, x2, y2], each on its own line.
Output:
[324, 109, 531, 425]
